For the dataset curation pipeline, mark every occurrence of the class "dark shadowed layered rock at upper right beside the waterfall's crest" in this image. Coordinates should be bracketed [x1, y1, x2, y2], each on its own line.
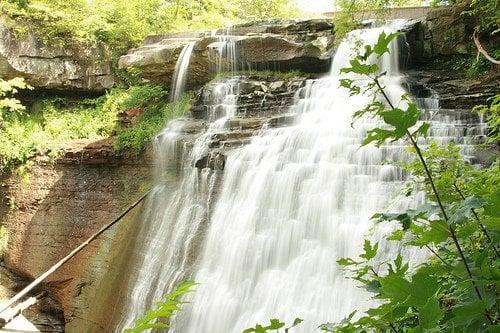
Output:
[403, 6, 500, 109]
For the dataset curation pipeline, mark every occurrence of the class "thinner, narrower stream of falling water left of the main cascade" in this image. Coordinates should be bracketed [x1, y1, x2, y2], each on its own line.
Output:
[116, 75, 252, 332]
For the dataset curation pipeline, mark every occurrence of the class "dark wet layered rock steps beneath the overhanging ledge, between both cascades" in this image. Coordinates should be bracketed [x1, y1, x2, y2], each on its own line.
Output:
[188, 76, 306, 170]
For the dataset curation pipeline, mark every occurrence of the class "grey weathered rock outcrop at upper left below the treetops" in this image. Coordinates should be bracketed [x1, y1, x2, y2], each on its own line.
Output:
[0, 16, 114, 93]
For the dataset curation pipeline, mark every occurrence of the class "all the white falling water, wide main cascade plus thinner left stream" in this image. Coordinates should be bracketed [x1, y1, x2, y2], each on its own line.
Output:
[118, 24, 481, 333]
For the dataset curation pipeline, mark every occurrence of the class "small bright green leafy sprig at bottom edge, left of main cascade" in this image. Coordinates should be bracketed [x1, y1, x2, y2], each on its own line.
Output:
[124, 281, 196, 333]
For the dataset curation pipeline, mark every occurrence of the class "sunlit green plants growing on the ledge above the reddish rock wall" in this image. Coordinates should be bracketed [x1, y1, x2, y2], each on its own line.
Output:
[0, 85, 190, 173]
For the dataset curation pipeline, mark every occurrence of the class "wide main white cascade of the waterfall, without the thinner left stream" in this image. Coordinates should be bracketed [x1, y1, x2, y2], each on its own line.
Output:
[174, 28, 484, 333]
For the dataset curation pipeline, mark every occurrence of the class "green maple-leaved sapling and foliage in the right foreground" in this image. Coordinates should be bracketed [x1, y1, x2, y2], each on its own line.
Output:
[328, 34, 500, 332]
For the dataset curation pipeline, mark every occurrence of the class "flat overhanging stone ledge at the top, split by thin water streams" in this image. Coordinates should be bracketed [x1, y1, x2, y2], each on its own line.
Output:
[119, 19, 334, 88]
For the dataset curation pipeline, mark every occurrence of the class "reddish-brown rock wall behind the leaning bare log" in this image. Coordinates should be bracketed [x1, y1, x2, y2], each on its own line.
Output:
[0, 140, 151, 332]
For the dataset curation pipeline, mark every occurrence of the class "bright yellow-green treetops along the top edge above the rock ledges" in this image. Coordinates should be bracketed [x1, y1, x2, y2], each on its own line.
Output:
[0, 0, 297, 55]
